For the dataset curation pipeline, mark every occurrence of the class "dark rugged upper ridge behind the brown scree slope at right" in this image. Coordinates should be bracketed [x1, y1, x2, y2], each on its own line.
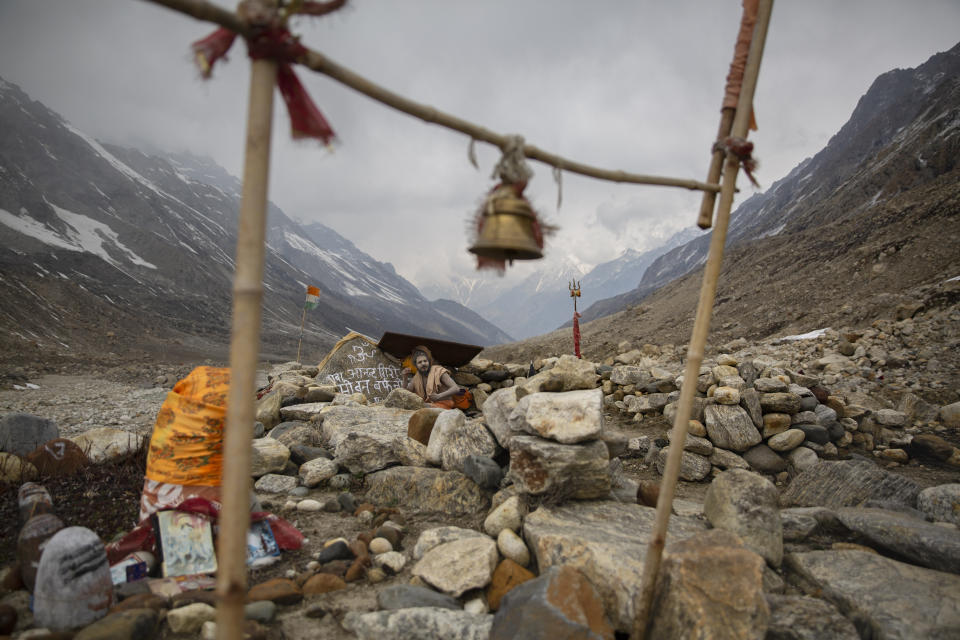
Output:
[572, 45, 960, 320]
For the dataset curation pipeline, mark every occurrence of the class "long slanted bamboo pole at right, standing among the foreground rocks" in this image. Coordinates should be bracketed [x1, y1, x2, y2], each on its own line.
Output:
[632, 0, 773, 640]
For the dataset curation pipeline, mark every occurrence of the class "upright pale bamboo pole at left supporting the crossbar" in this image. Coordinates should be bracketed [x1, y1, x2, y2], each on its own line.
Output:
[217, 52, 277, 640]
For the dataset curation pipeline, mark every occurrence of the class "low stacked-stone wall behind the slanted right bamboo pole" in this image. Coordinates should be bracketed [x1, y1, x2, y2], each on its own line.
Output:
[600, 344, 960, 483]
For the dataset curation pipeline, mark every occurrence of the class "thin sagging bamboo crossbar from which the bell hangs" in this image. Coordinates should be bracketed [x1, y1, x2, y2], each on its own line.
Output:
[149, 0, 720, 193]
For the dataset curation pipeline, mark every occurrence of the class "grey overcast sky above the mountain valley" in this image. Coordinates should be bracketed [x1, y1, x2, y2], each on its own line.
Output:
[0, 0, 960, 286]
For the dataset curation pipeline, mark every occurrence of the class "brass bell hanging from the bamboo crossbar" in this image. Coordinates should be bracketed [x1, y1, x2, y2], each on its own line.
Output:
[470, 186, 543, 261]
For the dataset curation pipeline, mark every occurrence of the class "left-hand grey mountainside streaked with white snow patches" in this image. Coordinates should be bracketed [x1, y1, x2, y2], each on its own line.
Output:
[0, 80, 509, 358]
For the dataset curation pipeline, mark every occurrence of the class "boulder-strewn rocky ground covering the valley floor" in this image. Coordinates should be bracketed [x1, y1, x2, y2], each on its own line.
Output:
[0, 324, 960, 639]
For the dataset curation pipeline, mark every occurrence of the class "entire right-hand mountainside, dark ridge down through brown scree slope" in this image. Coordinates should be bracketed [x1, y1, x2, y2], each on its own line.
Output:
[484, 45, 960, 362]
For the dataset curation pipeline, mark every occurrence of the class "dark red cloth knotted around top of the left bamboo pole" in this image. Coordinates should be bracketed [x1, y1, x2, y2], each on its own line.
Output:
[191, 26, 336, 144]
